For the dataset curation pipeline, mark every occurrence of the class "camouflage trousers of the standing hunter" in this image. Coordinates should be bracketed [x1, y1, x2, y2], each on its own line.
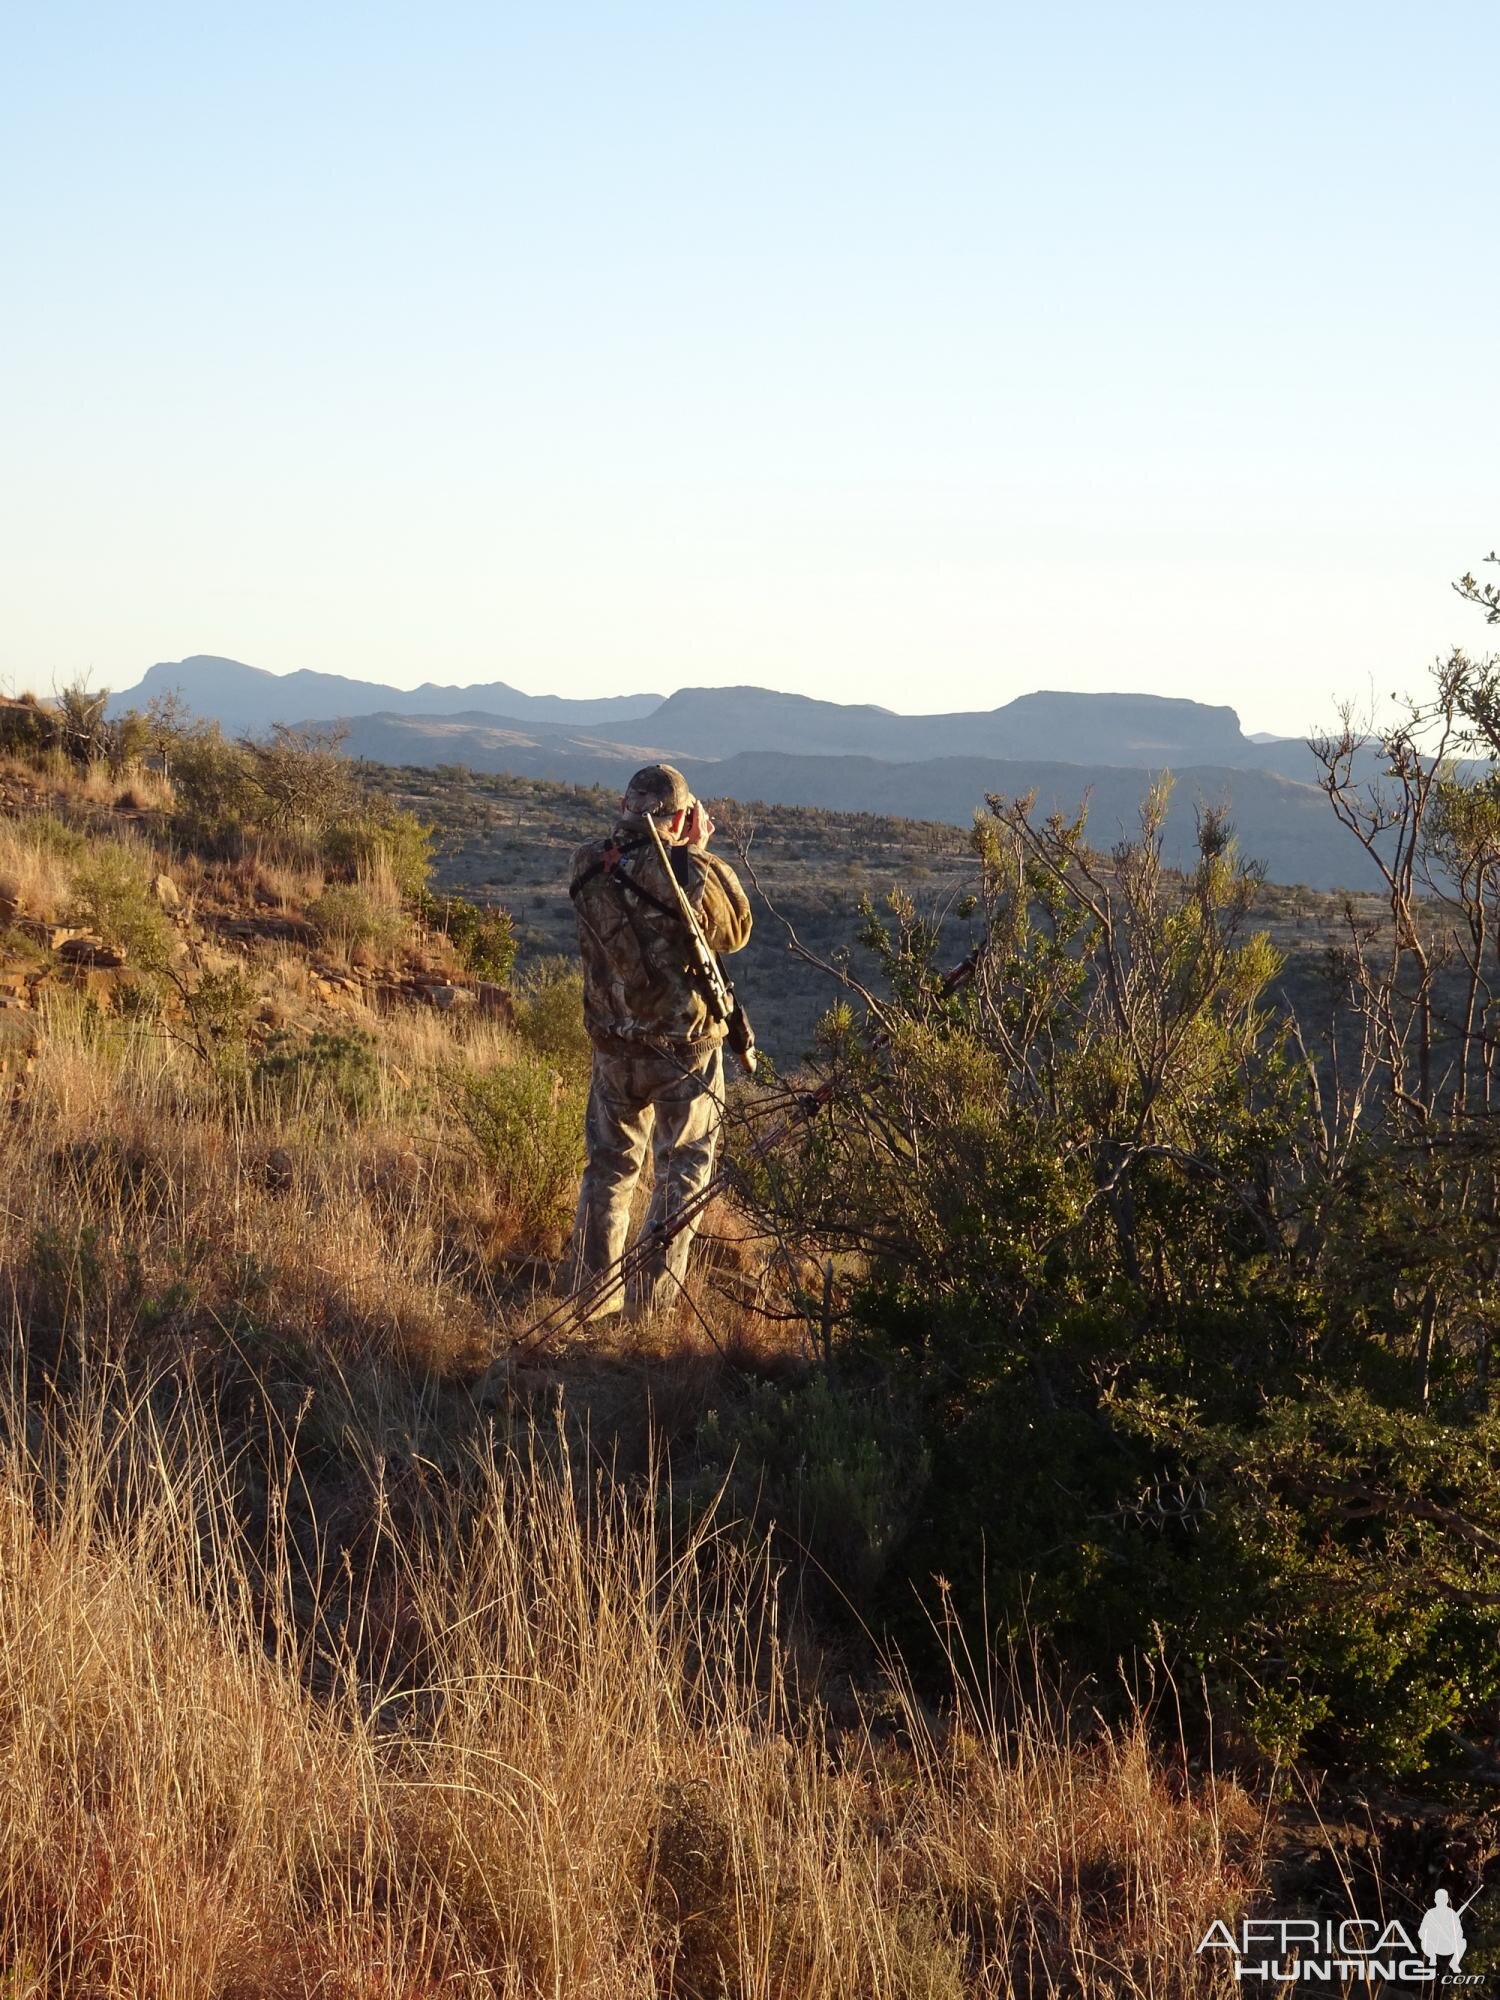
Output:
[568, 1044, 724, 1316]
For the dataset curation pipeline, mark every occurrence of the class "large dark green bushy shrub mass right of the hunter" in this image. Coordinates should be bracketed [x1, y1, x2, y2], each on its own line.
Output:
[742, 764, 1500, 1780]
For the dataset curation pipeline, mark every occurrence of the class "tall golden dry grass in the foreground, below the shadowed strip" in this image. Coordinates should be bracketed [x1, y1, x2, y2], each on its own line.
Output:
[0, 1368, 1256, 2000]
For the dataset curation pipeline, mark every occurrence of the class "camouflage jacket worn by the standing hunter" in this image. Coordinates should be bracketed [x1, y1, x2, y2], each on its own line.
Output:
[570, 826, 750, 1046]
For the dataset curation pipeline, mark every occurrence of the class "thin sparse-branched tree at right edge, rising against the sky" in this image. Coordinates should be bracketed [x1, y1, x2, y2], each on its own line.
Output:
[1308, 600, 1500, 1406]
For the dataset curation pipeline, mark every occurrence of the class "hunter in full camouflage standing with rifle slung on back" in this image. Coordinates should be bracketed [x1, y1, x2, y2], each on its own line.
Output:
[568, 764, 750, 1316]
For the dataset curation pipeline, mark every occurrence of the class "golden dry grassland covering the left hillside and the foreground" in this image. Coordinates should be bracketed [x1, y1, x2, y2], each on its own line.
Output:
[0, 740, 1266, 2000]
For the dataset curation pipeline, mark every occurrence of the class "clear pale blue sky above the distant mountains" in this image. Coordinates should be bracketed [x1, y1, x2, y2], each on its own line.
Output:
[0, 0, 1500, 732]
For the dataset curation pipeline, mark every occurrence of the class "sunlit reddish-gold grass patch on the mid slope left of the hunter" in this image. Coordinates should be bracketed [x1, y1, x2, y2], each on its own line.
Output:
[0, 992, 494, 1372]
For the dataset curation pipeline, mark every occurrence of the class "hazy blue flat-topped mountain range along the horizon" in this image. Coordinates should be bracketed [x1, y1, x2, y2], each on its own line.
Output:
[110, 654, 1372, 888]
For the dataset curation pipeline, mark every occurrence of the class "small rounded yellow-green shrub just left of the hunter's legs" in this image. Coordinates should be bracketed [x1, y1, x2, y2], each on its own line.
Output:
[452, 1052, 584, 1246]
